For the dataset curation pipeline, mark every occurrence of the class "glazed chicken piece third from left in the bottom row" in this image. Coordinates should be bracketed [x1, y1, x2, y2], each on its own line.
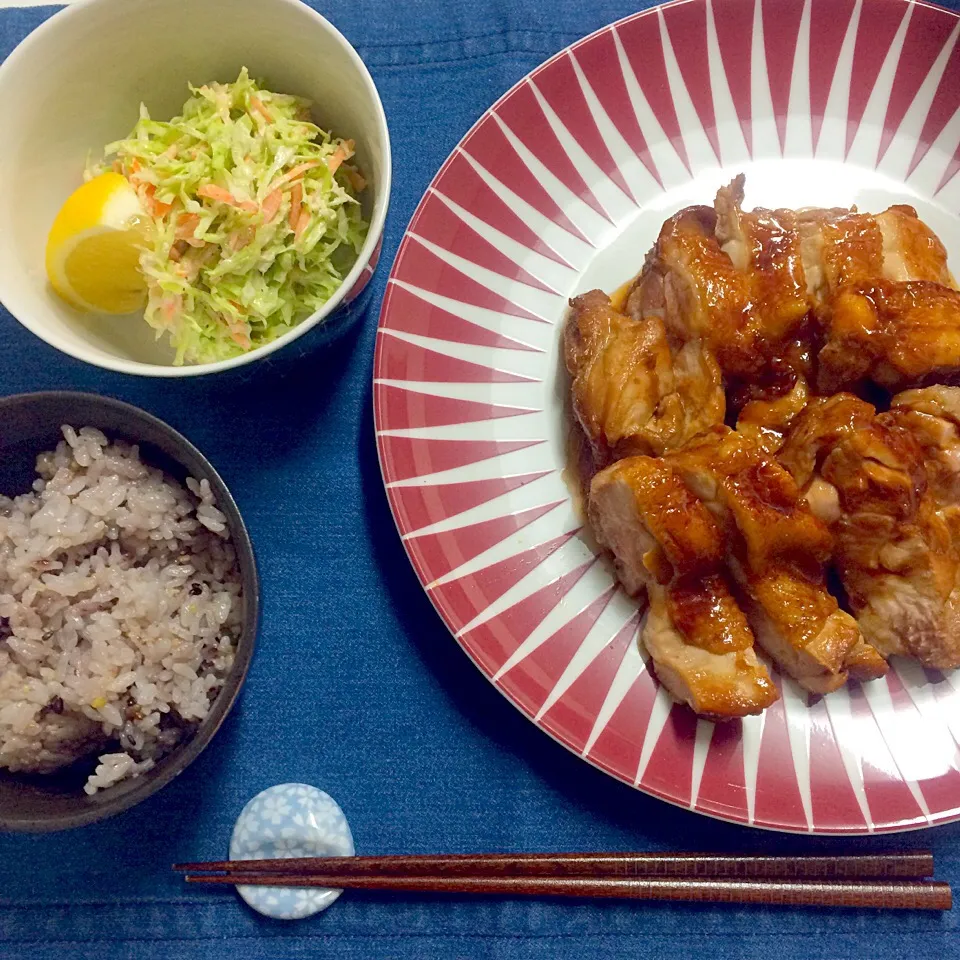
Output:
[780, 394, 960, 668]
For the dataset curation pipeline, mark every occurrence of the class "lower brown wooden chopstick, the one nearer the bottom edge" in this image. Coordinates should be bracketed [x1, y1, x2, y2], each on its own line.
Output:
[184, 872, 953, 910]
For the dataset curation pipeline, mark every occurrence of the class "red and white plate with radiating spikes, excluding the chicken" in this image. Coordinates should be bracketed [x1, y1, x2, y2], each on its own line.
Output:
[374, 0, 960, 833]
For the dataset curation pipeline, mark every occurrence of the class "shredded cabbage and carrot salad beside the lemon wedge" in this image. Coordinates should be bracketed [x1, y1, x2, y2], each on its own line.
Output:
[87, 68, 368, 364]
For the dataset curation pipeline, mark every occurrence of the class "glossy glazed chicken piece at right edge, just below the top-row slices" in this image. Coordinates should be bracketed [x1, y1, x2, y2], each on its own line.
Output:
[818, 280, 960, 393]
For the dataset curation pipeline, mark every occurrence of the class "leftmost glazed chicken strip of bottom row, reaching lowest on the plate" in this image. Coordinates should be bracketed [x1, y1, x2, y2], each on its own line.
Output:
[589, 457, 778, 719]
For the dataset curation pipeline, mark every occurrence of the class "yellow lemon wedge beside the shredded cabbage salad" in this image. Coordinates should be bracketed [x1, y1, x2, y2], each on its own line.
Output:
[46, 173, 147, 314]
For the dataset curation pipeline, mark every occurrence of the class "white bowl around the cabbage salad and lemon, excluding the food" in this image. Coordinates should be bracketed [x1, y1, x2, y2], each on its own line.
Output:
[0, 0, 390, 377]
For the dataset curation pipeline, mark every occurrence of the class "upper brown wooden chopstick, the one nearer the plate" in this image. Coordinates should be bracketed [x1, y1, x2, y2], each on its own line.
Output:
[173, 850, 933, 880]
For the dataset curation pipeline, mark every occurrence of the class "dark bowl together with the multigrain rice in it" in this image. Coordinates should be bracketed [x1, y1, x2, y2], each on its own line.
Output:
[0, 392, 259, 832]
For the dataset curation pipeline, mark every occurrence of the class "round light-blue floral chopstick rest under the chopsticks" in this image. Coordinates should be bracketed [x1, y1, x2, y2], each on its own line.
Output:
[230, 783, 355, 920]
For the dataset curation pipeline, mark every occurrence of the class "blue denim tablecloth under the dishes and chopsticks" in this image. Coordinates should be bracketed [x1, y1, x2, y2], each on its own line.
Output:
[0, 0, 960, 960]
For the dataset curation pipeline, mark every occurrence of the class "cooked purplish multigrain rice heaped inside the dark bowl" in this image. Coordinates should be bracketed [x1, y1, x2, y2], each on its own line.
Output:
[0, 426, 241, 794]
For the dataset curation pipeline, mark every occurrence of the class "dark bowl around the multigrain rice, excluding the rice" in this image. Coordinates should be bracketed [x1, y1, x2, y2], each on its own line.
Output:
[0, 390, 260, 833]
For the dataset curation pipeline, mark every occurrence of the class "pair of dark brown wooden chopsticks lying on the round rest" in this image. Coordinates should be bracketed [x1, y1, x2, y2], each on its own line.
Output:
[174, 850, 953, 910]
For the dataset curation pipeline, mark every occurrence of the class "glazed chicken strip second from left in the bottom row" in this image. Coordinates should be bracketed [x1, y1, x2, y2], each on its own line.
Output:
[666, 427, 862, 693]
